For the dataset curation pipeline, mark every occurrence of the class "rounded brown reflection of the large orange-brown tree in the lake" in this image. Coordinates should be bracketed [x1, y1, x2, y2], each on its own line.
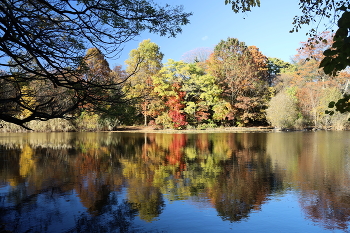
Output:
[206, 134, 282, 221]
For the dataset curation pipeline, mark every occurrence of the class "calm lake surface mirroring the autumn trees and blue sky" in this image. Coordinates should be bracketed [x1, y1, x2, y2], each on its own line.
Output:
[0, 132, 350, 232]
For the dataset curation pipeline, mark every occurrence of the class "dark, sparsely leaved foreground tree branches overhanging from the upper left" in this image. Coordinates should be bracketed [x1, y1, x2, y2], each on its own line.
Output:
[0, 0, 191, 127]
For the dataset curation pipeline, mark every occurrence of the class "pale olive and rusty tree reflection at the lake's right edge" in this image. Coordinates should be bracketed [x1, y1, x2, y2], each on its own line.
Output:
[294, 132, 350, 230]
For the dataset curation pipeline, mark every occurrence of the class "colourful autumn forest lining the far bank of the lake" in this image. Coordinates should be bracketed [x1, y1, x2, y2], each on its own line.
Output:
[1, 32, 350, 131]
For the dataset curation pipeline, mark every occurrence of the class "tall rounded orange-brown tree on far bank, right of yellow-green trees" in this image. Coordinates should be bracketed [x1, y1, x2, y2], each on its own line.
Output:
[207, 38, 268, 125]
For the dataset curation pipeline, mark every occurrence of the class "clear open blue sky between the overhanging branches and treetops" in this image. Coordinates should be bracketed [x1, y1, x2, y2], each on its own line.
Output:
[109, 0, 326, 68]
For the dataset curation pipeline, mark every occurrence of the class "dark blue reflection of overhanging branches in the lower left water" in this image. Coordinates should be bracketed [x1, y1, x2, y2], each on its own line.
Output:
[0, 185, 139, 233]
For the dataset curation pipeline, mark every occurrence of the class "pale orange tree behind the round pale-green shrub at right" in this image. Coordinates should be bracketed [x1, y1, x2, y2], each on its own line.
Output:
[294, 32, 349, 127]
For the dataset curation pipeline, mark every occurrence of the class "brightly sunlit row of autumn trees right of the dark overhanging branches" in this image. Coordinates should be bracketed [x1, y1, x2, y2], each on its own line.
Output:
[115, 32, 350, 129]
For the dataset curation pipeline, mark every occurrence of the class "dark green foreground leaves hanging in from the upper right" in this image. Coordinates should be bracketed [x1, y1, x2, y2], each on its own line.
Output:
[225, 0, 350, 120]
